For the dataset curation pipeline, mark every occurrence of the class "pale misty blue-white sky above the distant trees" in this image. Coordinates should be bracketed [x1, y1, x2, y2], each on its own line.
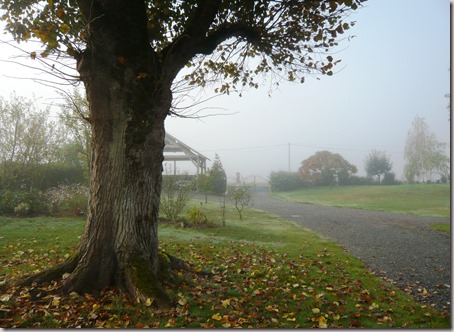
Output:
[0, 0, 451, 180]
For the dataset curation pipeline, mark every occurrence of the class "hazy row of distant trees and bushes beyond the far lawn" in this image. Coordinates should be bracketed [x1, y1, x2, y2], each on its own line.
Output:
[269, 117, 450, 191]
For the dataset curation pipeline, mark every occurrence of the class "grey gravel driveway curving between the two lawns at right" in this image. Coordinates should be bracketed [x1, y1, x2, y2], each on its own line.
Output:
[253, 193, 451, 312]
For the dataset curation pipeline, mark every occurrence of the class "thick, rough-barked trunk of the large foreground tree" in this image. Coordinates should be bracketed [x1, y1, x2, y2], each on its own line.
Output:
[58, 1, 172, 299]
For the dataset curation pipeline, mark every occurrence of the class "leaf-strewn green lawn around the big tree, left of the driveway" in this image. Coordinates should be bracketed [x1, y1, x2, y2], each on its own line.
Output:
[0, 201, 450, 328]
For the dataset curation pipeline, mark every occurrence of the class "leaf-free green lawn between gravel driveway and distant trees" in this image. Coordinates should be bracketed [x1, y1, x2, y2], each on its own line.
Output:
[274, 184, 450, 217]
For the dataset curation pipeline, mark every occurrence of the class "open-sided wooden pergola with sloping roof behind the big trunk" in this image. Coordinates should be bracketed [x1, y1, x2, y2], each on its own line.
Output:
[164, 133, 210, 175]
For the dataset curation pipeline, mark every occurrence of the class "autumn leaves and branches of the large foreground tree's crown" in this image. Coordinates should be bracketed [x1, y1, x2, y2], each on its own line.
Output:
[1, 0, 365, 97]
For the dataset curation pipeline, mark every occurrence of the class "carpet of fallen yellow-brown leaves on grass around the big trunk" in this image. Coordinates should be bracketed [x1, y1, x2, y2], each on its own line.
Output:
[0, 235, 449, 328]
